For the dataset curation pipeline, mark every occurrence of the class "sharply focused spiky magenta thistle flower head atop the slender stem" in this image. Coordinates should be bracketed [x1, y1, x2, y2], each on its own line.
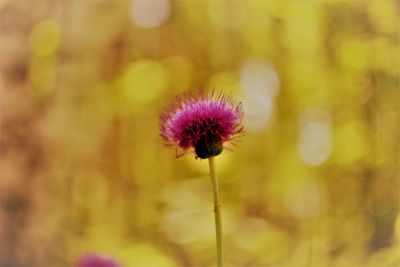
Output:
[160, 90, 243, 159]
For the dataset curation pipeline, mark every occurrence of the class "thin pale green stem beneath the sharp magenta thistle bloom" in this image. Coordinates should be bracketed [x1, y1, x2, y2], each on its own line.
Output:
[208, 157, 222, 267]
